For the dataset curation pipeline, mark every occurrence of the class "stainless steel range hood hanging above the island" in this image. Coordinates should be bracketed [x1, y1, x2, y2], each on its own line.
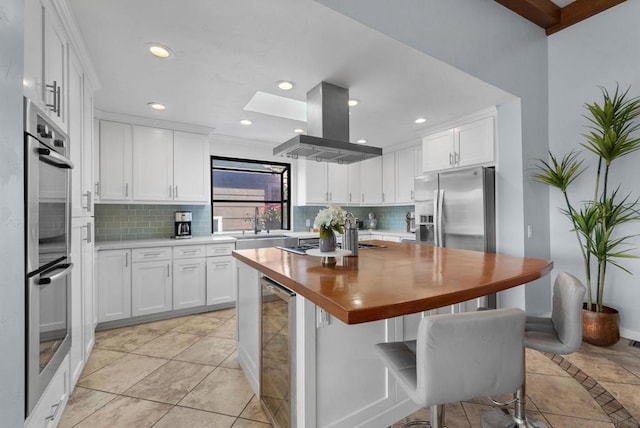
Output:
[273, 82, 382, 164]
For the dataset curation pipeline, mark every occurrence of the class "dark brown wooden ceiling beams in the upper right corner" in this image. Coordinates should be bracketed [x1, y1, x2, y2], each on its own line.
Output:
[495, 0, 626, 36]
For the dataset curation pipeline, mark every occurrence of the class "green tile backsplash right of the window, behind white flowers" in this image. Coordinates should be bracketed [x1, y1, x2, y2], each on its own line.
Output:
[293, 205, 414, 232]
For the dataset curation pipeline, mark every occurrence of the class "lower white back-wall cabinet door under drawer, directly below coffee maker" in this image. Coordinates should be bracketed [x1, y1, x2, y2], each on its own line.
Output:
[173, 257, 207, 310]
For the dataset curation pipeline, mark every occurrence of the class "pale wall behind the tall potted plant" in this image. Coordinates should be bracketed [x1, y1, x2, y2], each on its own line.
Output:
[549, 1, 640, 340]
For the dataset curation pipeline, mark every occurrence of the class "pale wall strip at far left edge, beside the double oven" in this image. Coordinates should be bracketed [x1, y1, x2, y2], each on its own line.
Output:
[0, 0, 25, 427]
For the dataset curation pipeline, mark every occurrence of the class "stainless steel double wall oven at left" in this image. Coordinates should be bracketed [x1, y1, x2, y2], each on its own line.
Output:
[24, 98, 73, 415]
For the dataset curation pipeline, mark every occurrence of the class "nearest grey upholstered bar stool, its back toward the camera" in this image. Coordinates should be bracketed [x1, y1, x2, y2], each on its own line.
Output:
[376, 308, 526, 428]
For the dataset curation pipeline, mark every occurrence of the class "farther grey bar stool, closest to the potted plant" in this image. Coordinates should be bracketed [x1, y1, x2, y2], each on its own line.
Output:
[483, 272, 586, 427]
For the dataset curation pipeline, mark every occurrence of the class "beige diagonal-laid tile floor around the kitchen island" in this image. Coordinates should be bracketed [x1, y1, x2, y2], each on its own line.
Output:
[60, 309, 640, 428]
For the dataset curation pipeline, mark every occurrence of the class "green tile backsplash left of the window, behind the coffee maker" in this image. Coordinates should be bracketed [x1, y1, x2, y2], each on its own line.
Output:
[95, 204, 211, 241]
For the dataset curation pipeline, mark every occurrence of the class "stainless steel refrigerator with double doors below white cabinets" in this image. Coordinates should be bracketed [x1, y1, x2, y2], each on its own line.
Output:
[415, 167, 496, 311]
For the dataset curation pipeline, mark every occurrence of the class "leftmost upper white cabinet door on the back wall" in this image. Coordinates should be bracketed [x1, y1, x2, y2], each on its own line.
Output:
[98, 120, 133, 201]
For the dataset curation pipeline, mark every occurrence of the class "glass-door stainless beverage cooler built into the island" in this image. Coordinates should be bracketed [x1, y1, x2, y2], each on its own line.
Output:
[260, 277, 296, 428]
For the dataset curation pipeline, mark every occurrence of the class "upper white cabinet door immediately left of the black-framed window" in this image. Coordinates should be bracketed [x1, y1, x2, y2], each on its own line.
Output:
[173, 131, 211, 202]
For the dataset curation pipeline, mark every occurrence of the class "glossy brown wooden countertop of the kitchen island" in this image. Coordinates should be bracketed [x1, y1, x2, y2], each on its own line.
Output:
[233, 241, 553, 324]
